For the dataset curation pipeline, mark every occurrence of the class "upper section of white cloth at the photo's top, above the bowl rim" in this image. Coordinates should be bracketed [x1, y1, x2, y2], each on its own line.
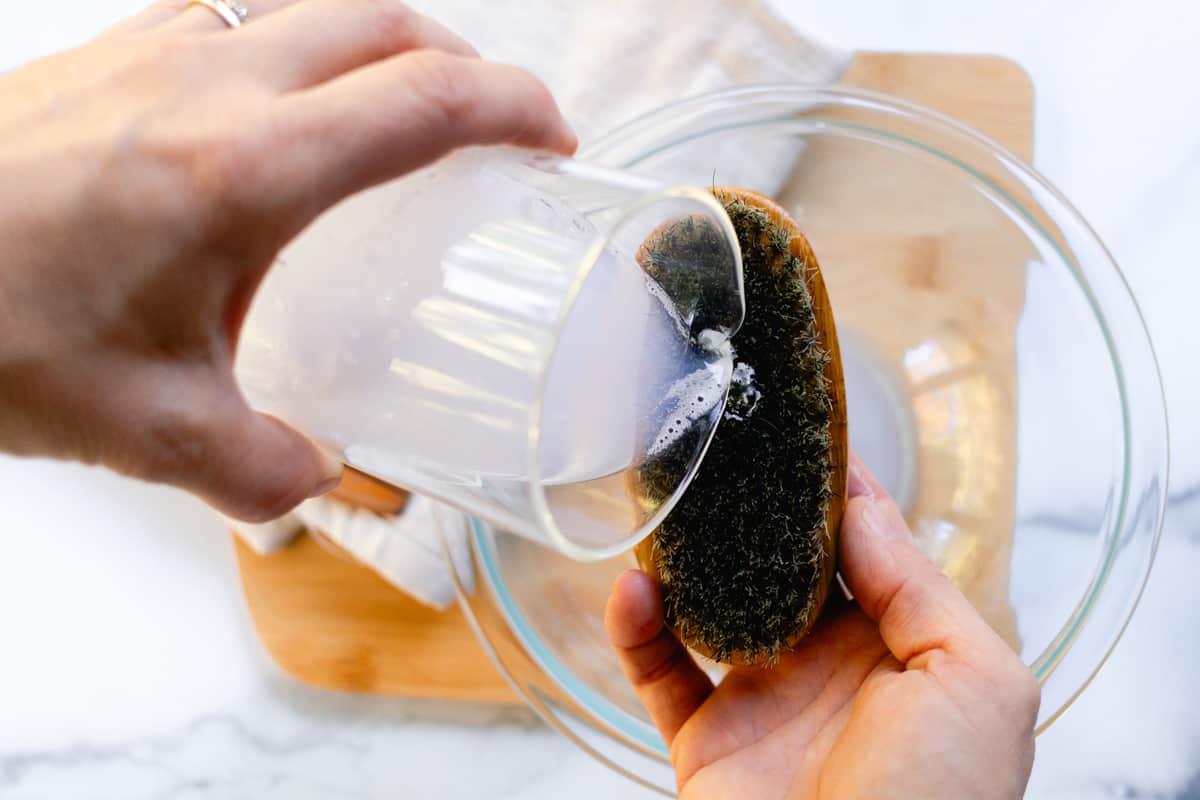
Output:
[408, 0, 851, 145]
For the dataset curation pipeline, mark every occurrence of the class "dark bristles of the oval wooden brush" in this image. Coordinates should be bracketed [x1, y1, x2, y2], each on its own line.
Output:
[640, 196, 832, 662]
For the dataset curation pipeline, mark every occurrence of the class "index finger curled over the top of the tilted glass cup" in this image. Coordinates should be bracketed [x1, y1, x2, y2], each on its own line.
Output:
[272, 50, 576, 207]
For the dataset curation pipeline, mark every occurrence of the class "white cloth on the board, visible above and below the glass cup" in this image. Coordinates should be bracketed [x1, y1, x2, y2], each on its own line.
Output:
[234, 0, 851, 608]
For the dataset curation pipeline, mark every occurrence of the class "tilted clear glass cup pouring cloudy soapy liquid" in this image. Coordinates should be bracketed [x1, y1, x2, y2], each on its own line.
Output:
[236, 150, 744, 559]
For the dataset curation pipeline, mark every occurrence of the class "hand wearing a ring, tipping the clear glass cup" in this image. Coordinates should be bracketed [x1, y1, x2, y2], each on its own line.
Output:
[0, 0, 575, 521]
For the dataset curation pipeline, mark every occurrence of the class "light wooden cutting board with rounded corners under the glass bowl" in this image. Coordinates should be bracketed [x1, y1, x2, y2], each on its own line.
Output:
[235, 53, 1033, 703]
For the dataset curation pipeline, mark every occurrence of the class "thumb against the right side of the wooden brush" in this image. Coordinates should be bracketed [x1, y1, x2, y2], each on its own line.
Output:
[841, 453, 1010, 668]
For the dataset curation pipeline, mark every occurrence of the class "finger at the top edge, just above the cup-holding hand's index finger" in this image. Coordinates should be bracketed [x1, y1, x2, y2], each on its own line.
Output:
[238, 0, 479, 90]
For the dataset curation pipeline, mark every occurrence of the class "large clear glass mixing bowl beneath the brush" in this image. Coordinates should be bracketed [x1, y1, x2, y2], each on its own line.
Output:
[441, 86, 1168, 794]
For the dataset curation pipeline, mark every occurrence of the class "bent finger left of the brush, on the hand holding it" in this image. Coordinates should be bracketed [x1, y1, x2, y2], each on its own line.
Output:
[605, 570, 713, 744]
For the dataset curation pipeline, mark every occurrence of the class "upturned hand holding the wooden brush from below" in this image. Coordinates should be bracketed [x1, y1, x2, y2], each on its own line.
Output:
[606, 458, 1039, 800]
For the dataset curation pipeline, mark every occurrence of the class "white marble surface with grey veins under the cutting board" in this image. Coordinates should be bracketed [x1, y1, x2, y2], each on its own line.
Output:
[0, 0, 1200, 800]
